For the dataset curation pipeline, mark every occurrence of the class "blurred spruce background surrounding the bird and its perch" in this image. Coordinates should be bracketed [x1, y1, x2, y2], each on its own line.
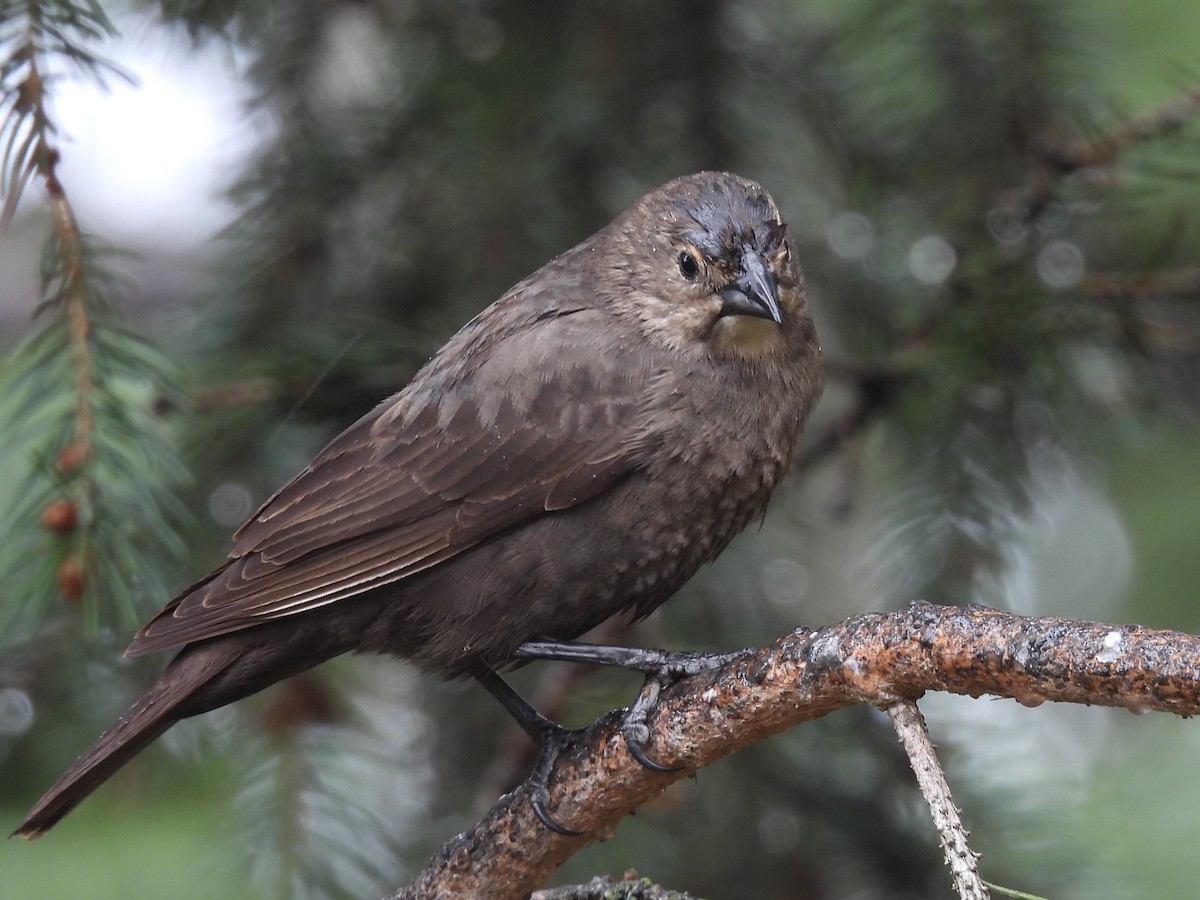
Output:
[0, 0, 1200, 900]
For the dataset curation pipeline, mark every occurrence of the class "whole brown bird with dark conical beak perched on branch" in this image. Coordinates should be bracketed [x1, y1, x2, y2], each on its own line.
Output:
[13, 172, 822, 839]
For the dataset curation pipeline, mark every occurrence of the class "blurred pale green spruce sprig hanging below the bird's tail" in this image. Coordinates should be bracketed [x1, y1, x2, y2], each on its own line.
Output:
[234, 660, 432, 898]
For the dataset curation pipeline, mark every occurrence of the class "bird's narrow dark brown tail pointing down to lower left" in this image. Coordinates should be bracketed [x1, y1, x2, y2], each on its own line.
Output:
[13, 652, 228, 840]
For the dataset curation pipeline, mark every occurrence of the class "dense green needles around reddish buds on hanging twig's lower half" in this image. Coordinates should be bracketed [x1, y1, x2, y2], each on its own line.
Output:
[0, 266, 188, 637]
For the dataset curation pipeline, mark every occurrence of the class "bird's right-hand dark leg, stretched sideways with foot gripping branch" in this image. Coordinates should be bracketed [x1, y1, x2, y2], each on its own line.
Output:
[516, 641, 745, 772]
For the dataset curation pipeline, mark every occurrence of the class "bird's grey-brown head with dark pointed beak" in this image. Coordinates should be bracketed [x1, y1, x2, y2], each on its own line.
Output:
[610, 172, 811, 361]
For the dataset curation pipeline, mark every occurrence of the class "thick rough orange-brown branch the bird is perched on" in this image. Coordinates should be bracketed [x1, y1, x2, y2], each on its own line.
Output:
[394, 602, 1200, 900]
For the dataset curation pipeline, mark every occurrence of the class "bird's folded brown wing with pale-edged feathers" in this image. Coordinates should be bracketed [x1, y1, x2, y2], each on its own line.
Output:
[126, 303, 644, 655]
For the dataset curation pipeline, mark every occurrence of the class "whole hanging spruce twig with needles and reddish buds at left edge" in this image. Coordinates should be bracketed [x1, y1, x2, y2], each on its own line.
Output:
[0, 1, 186, 640]
